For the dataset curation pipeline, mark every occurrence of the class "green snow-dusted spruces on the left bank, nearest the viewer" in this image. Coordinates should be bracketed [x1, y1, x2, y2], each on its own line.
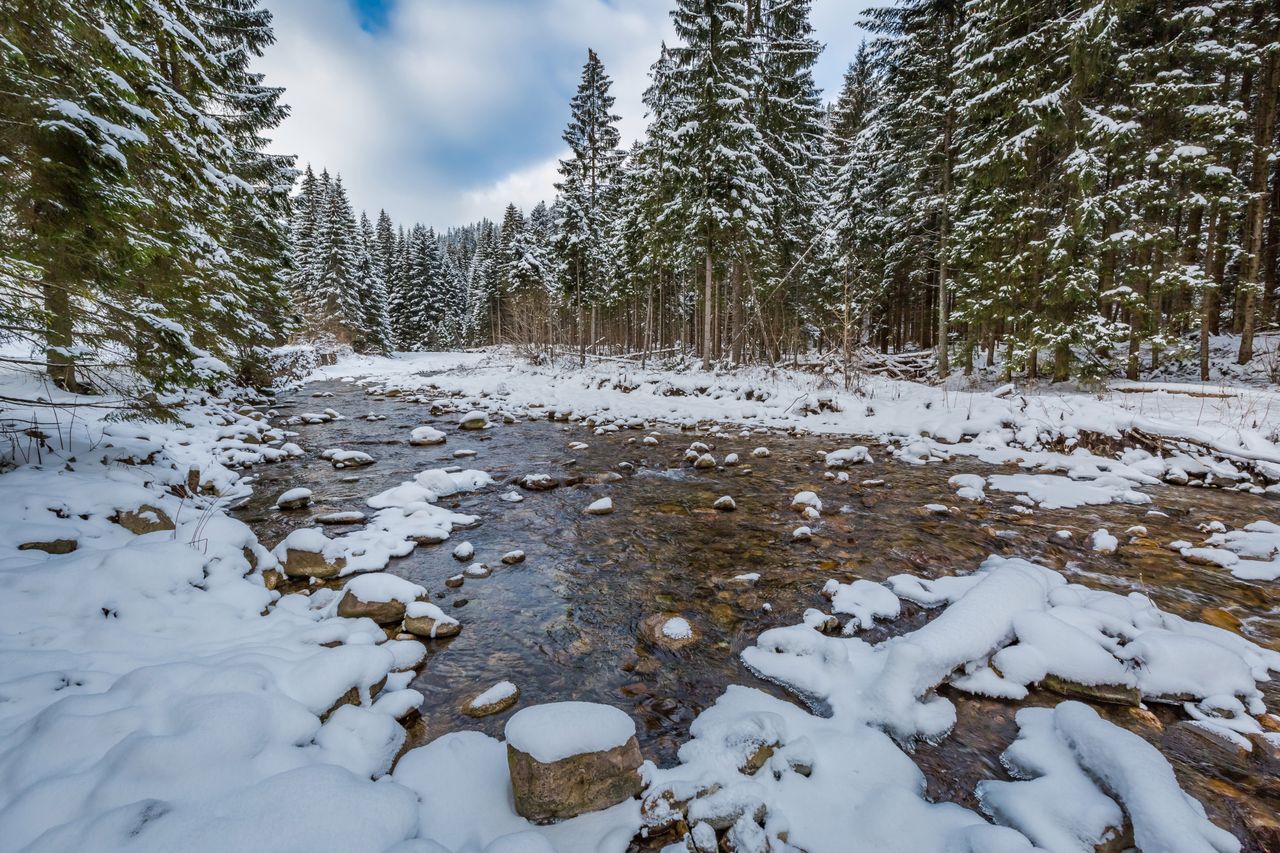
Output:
[0, 0, 296, 402]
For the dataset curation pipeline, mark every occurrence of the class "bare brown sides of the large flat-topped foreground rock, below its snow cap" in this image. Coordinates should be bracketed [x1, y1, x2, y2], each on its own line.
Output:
[507, 702, 644, 824]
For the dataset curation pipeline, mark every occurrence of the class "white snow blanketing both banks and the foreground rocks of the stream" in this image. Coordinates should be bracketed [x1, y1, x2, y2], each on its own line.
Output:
[0, 353, 1280, 853]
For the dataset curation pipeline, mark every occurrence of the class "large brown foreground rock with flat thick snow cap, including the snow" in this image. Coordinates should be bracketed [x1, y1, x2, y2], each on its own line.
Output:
[506, 702, 644, 824]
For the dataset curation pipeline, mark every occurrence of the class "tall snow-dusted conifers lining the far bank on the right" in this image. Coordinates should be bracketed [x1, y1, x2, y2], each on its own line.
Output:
[314, 0, 1280, 379]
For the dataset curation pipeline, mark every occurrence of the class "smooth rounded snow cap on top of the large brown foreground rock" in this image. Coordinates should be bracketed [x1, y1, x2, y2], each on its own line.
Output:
[506, 701, 637, 765]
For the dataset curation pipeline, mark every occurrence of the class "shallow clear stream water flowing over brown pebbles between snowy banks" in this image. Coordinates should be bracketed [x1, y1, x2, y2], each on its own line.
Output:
[239, 383, 1280, 852]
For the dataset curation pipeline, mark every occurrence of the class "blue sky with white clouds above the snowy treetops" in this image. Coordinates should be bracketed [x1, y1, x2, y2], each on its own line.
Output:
[260, 0, 869, 228]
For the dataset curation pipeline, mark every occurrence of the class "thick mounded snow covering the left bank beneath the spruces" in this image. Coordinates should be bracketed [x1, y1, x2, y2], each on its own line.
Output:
[0, 384, 425, 852]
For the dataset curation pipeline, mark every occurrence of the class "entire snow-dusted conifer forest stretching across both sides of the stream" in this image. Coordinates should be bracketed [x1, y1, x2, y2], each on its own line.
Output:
[0, 0, 1280, 389]
